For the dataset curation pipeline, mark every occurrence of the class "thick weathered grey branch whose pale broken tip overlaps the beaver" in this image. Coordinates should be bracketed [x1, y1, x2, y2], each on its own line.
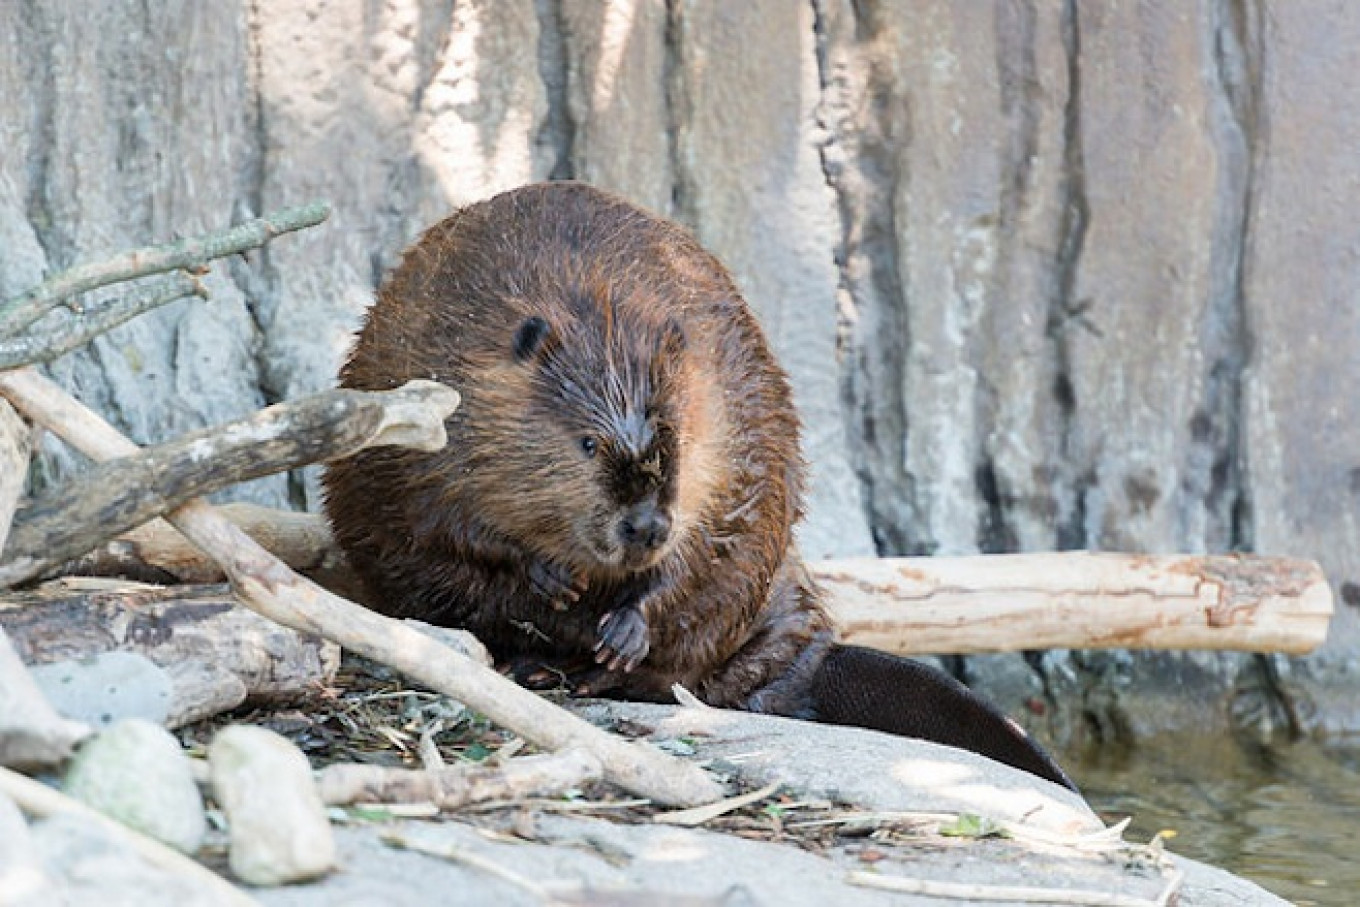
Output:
[0, 381, 458, 586]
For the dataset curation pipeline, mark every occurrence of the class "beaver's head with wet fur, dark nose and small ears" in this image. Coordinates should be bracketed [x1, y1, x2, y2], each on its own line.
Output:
[484, 291, 691, 572]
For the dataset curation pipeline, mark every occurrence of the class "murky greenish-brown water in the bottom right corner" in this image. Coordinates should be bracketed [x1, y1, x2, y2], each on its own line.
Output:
[1065, 734, 1360, 907]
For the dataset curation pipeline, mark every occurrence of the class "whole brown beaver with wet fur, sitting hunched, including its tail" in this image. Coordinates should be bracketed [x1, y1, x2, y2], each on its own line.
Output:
[324, 182, 1073, 787]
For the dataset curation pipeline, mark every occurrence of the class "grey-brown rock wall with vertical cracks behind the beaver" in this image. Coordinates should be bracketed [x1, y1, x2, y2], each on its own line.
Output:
[0, 0, 1360, 736]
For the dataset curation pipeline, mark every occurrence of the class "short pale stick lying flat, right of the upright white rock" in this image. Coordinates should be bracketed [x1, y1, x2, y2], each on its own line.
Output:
[317, 749, 601, 810]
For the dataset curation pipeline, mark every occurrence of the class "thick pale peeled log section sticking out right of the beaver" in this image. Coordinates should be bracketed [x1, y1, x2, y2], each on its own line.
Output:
[811, 551, 1331, 655]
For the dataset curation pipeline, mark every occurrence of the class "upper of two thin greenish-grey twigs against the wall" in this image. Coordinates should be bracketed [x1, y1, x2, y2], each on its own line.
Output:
[0, 203, 330, 337]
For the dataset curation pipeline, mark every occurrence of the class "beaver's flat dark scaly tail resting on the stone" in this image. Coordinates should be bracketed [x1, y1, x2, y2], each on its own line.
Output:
[812, 646, 1080, 793]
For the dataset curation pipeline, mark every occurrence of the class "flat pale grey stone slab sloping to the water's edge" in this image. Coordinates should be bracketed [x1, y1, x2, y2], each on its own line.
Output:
[252, 702, 1287, 907]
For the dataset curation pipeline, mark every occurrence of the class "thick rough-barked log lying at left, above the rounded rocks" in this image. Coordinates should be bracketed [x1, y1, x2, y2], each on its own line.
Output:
[0, 579, 340, 699]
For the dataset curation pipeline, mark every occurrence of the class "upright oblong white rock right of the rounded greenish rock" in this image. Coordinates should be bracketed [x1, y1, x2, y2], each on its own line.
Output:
[208, 725, 336, 885]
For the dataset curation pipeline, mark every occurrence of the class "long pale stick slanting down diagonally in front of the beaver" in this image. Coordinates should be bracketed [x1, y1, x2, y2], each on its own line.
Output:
[0, 369, 722, 806]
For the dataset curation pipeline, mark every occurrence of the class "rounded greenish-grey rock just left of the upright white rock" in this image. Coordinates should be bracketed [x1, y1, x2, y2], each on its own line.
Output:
[63, 718, 207, 854]
